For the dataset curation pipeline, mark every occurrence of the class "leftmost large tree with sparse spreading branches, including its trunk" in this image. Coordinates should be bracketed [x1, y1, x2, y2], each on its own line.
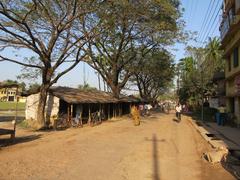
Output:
[0, 0, 91, 128]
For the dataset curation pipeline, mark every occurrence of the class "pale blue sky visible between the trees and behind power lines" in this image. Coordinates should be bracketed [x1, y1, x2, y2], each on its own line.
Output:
[0, 0, 222, 88]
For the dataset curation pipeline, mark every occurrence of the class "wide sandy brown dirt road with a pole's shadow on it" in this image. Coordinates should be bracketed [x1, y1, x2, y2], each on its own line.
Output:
[0, 114, 234, 180]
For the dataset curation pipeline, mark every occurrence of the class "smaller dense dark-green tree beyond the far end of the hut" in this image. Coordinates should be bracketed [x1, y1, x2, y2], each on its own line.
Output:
[130, 49, 174, 100]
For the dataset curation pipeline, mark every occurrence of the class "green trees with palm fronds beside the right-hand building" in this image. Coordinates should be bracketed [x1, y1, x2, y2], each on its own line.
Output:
[177, 38, 224, 106]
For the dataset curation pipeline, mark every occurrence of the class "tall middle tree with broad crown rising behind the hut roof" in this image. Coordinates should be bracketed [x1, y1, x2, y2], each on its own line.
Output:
[83, 0, 183, 97]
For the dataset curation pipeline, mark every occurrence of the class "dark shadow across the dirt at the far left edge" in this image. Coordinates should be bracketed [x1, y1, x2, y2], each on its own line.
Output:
[0, 134, 42, 147]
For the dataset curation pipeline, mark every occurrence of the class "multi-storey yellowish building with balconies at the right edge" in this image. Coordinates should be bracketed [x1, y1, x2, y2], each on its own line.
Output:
[219, 0, 240, 125]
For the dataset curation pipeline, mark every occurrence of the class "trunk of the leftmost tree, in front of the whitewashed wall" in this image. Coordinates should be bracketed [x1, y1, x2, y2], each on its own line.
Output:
[37, 85, 49, 129]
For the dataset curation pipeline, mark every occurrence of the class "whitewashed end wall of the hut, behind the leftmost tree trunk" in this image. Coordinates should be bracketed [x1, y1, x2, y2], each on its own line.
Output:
[25, 94, 60, 120]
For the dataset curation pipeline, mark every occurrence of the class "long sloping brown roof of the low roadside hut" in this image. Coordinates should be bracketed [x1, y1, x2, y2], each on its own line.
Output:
[50, 87, 140, 104]
